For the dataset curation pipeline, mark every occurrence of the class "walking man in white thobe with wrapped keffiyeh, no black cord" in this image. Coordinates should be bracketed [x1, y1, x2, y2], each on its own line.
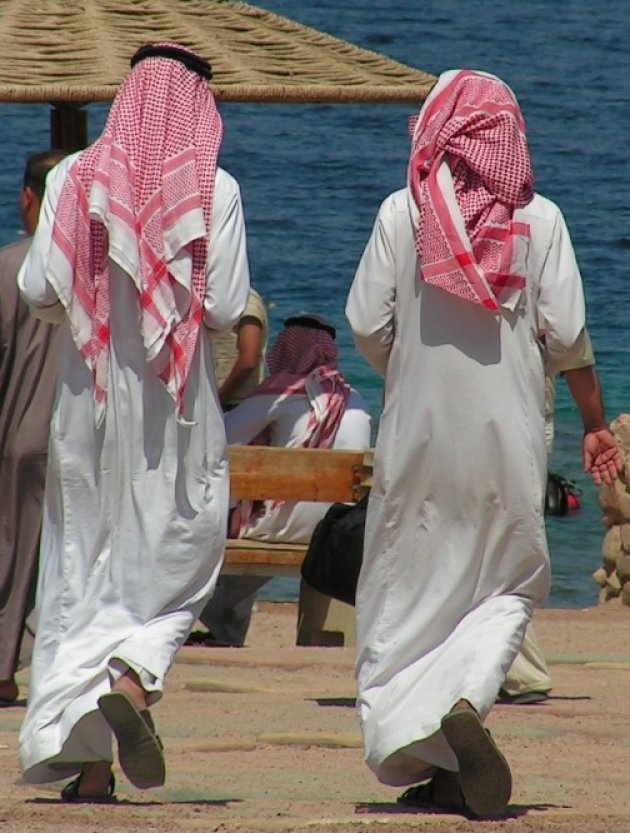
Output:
[346, 71, 620, 816]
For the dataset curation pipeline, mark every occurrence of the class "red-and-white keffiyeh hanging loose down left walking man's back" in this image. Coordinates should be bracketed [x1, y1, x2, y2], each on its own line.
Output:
[47, 44, 223, 424]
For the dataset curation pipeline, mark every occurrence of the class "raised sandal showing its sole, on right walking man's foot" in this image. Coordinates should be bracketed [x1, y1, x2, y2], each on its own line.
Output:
[442, 700, 512, 816]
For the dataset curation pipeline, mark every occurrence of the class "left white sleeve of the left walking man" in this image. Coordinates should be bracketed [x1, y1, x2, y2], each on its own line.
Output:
[17, 154, 76, 323]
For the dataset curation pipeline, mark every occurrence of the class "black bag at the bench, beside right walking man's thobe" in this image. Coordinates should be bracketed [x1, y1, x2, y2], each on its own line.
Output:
[302, 494, 369, 605]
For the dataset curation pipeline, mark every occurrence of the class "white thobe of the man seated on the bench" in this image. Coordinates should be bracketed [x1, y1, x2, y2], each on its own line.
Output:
[225, 388, 371, 544]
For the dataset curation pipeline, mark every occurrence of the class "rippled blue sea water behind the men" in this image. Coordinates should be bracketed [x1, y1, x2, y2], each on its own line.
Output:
[0, 0, 630, 607]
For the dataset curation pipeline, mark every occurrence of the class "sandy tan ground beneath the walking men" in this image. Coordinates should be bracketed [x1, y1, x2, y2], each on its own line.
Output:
[0, 604, 630, 833]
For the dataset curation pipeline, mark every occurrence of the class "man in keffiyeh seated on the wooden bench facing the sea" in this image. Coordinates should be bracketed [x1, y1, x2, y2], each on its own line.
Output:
[197, 315, 370, 645]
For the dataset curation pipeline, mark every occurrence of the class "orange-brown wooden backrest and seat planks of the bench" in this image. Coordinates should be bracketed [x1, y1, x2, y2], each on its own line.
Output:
[223, 445, 373, 576]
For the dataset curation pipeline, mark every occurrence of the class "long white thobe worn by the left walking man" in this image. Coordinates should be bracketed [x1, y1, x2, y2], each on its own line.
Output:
[19, 158, 249, 783]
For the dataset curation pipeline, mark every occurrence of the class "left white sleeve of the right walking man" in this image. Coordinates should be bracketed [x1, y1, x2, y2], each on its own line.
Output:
[346, 195, 396, 376]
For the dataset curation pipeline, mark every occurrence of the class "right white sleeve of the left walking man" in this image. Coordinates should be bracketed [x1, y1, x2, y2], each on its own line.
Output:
[204, 169, 249, 333]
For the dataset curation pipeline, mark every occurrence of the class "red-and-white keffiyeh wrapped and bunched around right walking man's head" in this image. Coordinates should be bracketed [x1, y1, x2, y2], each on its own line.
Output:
[408, 70, 534, 311]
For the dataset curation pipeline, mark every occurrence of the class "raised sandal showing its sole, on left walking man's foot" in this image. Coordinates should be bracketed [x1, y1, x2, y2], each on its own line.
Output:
[98, 691, 166, 790]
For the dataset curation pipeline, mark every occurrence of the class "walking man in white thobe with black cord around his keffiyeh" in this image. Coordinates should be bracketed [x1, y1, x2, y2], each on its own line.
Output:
[19, 44, 249, 801]
